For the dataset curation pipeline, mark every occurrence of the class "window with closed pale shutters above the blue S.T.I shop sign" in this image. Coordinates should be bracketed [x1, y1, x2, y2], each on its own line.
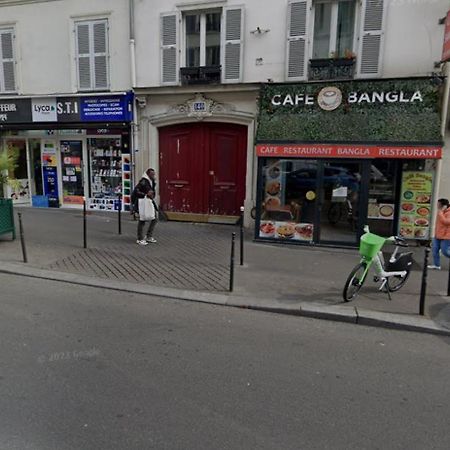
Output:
[75, 19, 109, 91]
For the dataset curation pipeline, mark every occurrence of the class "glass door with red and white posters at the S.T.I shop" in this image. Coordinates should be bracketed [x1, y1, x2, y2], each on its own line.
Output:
[61, 140, 84, 205]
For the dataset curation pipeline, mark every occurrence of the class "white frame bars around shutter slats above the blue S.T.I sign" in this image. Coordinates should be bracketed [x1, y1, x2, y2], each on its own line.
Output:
[73, 17, 111, 92]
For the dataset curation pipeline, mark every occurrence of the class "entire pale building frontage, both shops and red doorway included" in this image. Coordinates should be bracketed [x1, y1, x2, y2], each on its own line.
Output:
[0, 0, 450, 245]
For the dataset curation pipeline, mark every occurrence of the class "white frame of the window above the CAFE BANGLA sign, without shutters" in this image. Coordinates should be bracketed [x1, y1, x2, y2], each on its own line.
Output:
[308, 0, 361, 60]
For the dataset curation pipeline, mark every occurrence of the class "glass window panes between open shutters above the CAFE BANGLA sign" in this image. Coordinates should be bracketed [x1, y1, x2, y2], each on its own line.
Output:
[312, 0, 356, 59]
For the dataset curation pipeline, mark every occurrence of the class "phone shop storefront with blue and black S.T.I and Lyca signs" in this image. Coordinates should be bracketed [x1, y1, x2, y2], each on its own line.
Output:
[0, 93, 133, 210]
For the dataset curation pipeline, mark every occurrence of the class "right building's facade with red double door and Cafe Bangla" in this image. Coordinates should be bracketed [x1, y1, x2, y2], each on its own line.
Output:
[134, 0, 450, 245]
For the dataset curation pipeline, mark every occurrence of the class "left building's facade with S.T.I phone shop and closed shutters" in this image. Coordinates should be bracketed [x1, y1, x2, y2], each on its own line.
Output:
[0, 0, 133, 209]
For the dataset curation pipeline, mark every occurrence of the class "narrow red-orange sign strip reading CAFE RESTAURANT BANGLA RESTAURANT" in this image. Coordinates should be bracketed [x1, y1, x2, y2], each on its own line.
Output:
[256, 144, 442, 159]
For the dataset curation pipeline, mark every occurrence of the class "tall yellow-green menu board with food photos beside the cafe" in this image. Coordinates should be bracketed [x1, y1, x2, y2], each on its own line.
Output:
[399, 172, 433, 239]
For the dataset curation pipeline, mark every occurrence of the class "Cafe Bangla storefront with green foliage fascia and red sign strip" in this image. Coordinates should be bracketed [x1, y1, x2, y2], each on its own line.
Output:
[255, 79, 442, 246]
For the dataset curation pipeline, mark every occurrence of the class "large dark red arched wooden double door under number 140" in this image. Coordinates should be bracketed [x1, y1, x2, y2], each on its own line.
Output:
[159, 123, 247, 216]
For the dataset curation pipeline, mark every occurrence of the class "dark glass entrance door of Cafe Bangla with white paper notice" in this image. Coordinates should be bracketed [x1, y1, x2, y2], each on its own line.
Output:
[317, 160, 363, 244]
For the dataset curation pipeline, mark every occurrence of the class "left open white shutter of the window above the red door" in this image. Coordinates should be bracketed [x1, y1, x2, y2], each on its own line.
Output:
[160, 12, 180, 85]
